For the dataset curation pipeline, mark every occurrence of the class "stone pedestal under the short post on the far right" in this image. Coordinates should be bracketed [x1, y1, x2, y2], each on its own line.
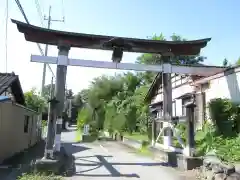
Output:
[177, 154, 203, 171]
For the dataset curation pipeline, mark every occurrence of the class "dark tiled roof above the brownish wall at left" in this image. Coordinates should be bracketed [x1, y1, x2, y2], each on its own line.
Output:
[0, 73, 25, 105]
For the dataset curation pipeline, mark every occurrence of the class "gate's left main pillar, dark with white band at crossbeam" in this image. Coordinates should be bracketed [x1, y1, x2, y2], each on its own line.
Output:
[54, 45, 70, 152]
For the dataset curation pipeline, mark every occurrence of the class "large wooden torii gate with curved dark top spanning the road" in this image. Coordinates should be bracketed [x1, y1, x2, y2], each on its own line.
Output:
[12, 20, 223, 158]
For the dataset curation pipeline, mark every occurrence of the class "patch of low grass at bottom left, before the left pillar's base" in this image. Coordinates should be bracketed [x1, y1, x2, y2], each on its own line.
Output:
[18, 174, 63, 180]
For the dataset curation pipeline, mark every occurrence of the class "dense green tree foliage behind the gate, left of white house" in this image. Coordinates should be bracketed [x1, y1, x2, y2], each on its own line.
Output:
[76, 34, 205, 133]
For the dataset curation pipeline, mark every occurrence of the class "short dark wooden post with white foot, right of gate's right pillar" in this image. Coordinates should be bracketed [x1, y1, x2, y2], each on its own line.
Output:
[185, 101, 196, 156]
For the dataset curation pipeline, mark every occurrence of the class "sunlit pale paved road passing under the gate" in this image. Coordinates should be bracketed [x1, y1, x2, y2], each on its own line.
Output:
[62, 127, 184, 180]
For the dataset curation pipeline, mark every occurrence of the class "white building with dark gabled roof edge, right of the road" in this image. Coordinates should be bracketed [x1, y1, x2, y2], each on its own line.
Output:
[146, 67, 240, 128]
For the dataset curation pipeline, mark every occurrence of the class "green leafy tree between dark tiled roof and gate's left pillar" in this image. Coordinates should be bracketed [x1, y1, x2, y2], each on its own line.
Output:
[24, 89, 47, 113]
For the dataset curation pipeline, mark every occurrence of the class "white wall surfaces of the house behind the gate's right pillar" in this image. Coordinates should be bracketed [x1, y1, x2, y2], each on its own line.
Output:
[151, 67, 240, 127]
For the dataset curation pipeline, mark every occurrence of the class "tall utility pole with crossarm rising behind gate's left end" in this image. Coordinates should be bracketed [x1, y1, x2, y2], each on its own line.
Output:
[41, 6, 65, 96]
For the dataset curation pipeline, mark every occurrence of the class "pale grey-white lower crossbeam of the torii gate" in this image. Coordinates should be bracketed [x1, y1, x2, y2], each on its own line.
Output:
[31, 55, 224, 76]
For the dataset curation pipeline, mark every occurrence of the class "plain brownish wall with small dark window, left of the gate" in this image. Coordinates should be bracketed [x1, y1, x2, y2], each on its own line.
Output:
[0, 102, 38, 162]
